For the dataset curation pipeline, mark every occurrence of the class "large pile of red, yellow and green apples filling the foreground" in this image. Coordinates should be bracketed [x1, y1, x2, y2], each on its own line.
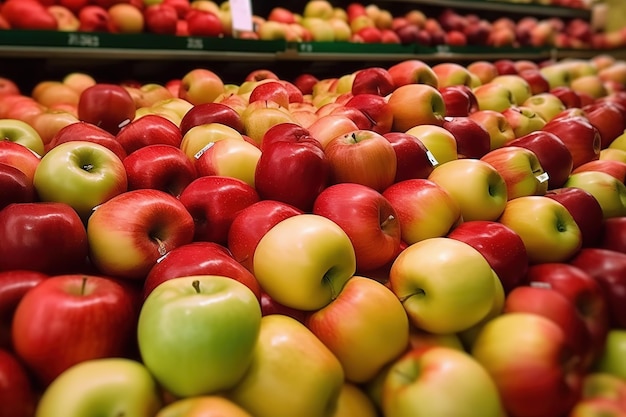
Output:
[0, 51, 626, 417]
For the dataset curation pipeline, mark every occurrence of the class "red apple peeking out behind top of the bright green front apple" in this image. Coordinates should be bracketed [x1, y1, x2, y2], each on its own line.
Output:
[143, 242, 261, 301]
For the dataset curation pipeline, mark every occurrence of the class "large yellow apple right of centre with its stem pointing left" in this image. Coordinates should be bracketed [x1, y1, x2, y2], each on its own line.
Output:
[389, 237, 497, 334]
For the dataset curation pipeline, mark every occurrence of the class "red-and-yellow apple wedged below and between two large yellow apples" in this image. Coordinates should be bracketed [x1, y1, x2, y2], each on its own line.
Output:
[305, 276, 409, 383]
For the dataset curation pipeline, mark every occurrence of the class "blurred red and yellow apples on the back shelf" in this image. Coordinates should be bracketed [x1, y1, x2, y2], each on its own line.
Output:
[0, 0, 626, 49]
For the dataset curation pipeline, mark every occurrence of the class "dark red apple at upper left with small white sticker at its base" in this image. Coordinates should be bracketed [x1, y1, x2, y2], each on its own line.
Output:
[77, 83, 136, 135]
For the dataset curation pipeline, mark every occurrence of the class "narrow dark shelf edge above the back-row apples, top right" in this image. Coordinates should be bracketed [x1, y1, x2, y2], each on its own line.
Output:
[390, 0, 592, 20]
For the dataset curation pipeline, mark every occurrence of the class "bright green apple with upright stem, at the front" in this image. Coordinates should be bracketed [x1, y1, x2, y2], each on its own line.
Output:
[137, 275, 261, 397]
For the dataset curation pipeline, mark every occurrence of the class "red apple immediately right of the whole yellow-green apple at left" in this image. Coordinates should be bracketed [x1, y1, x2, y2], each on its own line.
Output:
[122, 144, 197, 198]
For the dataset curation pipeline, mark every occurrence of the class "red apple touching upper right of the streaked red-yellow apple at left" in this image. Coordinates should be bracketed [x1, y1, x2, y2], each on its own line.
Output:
[180, 175, 259, 245]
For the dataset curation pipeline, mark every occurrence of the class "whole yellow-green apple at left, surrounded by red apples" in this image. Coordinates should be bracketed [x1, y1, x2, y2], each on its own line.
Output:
[33, 141, 128, 219]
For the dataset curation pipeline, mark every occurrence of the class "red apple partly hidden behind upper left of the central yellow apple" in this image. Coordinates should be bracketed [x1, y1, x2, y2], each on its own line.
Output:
[227, 200, 303, 271]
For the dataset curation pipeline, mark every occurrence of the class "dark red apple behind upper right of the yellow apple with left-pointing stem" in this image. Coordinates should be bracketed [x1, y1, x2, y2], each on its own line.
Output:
[447, 220, 529, 294]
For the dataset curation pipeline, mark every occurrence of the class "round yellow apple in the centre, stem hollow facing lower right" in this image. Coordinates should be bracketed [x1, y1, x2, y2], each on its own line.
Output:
[253, 213, 356, 311]
